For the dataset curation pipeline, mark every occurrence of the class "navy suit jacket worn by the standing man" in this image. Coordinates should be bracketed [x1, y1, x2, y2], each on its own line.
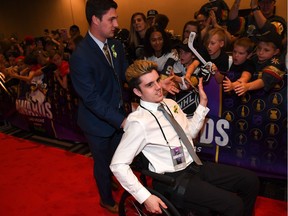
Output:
[69, 33, 128, 137]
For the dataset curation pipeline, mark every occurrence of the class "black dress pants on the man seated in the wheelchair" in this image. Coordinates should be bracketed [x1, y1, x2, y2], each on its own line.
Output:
[159, 162, 259, 216]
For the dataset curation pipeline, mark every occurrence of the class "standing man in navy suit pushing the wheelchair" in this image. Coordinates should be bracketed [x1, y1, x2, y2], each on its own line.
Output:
[70, 0, 128, 213]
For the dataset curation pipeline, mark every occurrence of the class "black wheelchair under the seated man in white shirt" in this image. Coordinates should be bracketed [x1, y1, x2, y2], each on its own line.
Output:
[119, 153, 218, 216]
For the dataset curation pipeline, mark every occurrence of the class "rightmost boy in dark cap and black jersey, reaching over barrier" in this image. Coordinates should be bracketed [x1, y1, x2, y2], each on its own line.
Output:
[234, 32, 285, 96]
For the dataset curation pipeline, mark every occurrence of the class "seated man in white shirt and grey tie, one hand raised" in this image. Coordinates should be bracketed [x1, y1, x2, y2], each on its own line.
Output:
[110, 60, 259, 216]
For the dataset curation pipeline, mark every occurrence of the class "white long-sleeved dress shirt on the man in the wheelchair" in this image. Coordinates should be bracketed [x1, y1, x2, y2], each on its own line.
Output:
[110, 99, 209, 203]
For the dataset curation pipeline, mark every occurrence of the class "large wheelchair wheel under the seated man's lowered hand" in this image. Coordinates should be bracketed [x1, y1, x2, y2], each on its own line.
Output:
[119, 188, 181, 216]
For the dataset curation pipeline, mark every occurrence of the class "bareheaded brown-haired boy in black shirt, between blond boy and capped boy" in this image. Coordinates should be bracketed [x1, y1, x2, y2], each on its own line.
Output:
[223, 37, 255, 92]
